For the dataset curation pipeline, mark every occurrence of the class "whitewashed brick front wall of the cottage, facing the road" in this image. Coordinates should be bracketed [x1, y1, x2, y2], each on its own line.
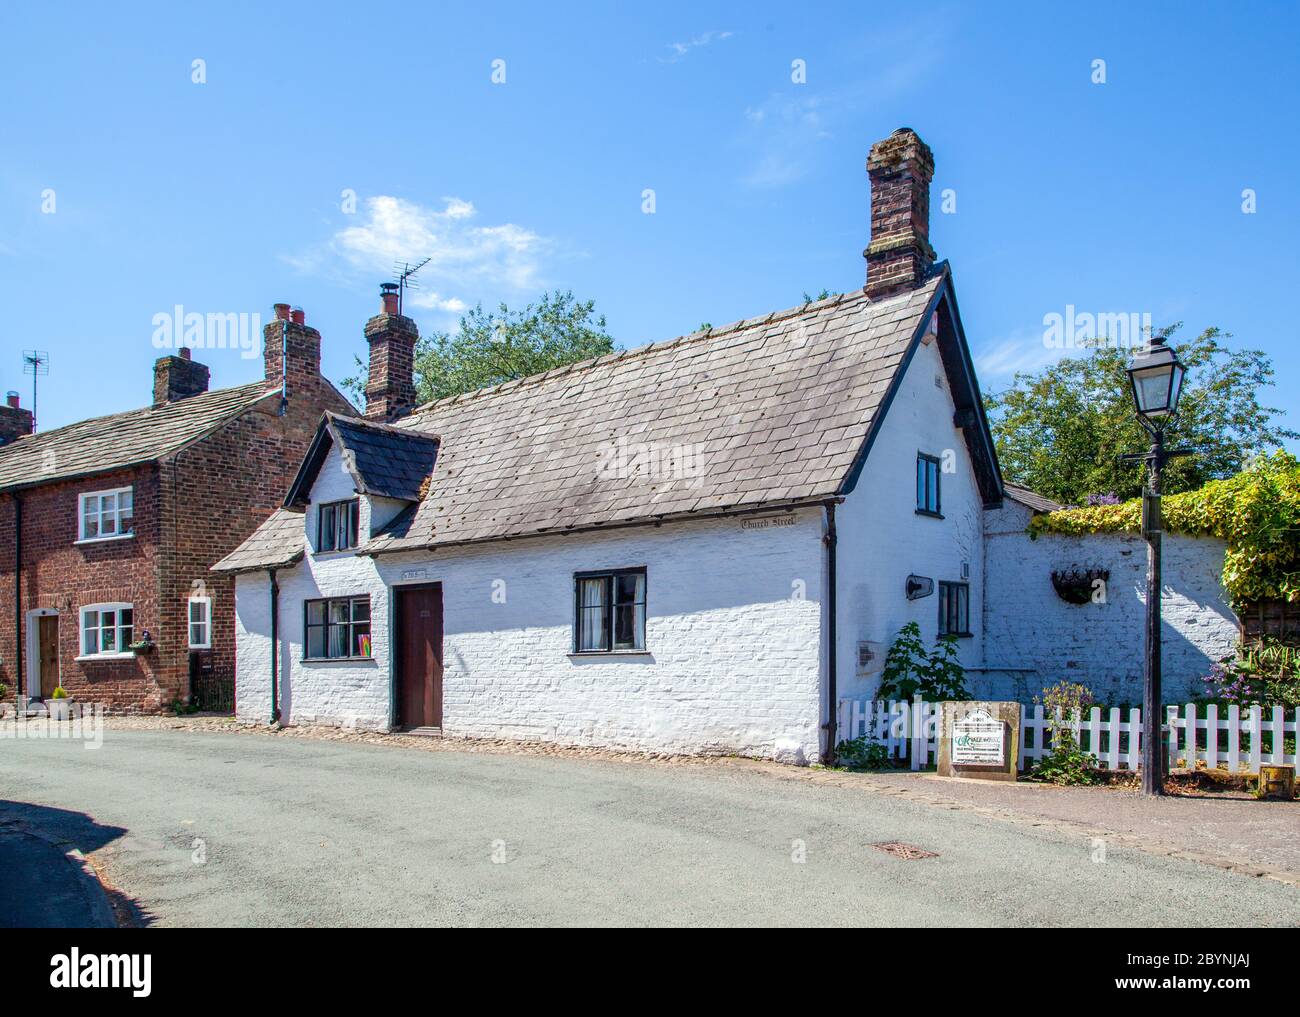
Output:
[238, 442, 823, 761]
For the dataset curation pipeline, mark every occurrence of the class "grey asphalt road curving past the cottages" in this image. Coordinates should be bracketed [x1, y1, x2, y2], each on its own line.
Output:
[0, 731, 1300, 926]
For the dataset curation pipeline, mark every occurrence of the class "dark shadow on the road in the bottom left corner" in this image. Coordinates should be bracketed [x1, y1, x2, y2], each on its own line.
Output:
[0, 800, 153, 927]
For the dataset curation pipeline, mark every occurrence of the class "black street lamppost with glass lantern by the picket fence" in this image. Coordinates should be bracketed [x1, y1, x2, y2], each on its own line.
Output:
[1125, 336, 1188, 795]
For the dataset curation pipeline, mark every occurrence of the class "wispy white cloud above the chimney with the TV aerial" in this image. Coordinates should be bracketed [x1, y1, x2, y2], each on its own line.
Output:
[285, 194, 551, 313]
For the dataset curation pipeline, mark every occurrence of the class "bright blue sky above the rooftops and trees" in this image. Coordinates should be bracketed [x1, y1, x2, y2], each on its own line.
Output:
[0, 0, 1300, 447]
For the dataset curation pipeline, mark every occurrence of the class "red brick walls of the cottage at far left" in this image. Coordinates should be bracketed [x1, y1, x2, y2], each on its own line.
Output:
[0, 381, 355, 713]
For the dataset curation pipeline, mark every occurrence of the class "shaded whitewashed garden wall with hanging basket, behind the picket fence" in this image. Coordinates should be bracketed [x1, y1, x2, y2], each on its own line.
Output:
[969, 501, 1238, 704]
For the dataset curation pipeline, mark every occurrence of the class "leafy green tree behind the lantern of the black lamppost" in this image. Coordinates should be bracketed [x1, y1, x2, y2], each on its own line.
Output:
[984, 323, 1300, 505]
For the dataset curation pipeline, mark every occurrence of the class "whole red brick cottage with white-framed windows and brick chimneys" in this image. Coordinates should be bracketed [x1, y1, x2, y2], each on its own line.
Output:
[0, 304, 351, 713]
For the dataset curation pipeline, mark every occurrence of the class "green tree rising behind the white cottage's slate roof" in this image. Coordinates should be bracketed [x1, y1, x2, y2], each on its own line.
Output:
[343, 291, 614, 403]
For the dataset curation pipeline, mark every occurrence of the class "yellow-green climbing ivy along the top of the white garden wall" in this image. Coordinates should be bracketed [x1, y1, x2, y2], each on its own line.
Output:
[1030, 449, 1300, 606]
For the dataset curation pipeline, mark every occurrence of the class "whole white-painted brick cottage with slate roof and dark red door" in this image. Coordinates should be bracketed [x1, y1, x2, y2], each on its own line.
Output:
[217, 129, 1237, 761]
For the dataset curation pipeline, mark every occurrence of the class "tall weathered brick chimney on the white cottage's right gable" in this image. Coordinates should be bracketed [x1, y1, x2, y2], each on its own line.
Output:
[862, 127, 935, 299]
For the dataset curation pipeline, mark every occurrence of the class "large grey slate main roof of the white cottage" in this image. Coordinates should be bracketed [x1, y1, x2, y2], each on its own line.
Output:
[361, 273, 948, 554]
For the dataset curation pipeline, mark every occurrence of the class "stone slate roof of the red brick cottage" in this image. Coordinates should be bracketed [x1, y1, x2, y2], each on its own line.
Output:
[0, 381, 278, 490]
